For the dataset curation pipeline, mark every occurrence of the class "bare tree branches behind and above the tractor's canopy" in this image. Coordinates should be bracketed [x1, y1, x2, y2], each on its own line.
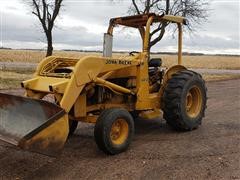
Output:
[129, 0, 209, 48]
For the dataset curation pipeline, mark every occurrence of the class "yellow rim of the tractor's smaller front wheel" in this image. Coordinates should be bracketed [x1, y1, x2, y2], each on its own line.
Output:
[110, 119, 129, 145]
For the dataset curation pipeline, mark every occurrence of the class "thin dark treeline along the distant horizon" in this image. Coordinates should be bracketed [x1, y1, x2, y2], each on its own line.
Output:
[0, 47, 240, 57]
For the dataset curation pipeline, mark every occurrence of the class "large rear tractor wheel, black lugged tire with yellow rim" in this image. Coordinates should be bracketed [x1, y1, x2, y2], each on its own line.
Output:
[162, 70, 207, 130]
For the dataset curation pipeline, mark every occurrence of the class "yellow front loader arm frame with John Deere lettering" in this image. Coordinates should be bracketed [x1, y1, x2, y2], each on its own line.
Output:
[22, 56, 140, 113]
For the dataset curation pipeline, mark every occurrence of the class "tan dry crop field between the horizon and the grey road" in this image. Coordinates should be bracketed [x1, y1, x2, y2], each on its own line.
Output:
[0, 50, 240, 69]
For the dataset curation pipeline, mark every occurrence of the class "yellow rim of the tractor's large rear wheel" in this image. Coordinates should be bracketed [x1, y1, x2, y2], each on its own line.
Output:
[185, 86, 203, 118]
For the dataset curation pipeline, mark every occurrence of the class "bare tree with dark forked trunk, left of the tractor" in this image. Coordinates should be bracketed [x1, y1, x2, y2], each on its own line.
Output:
[31, 0, 63, 56]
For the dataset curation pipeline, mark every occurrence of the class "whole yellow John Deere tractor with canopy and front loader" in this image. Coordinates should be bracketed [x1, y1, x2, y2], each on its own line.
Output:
[0, 14, 206, 155]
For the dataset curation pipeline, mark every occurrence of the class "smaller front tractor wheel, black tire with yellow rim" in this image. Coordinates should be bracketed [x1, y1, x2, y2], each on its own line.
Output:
[94, 108, 134, 155]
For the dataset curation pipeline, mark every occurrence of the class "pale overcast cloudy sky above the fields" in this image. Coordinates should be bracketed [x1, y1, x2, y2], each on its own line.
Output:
[0, 0, 240, 54]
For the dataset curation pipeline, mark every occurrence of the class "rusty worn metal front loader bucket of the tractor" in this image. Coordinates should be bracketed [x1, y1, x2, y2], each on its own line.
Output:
[0, 93, 68, 156]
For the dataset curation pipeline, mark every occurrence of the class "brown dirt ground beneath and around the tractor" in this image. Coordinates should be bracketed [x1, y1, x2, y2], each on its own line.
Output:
[0, 79, 240, 180]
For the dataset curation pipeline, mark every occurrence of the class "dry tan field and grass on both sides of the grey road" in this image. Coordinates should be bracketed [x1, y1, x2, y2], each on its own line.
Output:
[0, 50, 240, 89]
